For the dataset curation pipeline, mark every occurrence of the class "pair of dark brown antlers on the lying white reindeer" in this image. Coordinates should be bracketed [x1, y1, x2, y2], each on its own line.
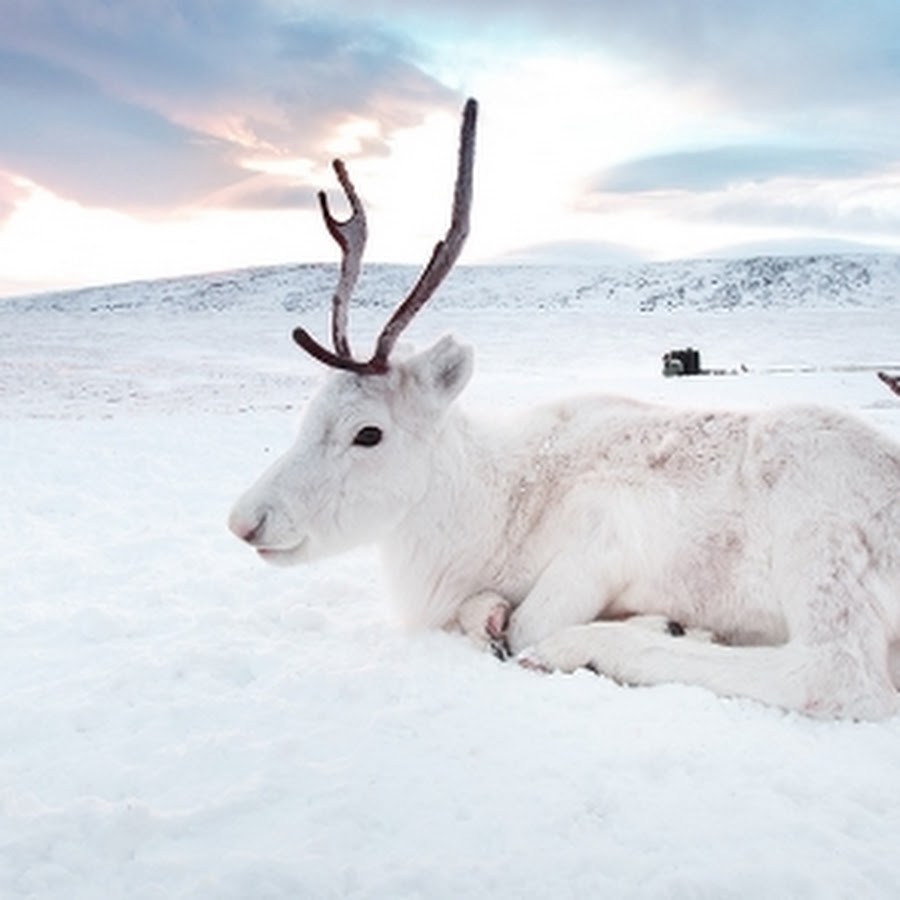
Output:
[294, 93, 478, 375]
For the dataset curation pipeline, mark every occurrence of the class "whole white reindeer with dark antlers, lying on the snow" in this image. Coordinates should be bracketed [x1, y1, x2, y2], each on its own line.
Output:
[230, 101, 900, 718]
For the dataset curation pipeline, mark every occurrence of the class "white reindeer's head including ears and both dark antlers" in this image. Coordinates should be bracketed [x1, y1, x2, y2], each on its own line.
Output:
[229, 100, 477, 564]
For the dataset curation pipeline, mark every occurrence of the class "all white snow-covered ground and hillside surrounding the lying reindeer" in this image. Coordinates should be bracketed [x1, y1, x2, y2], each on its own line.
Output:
[0, 257, 900, 900]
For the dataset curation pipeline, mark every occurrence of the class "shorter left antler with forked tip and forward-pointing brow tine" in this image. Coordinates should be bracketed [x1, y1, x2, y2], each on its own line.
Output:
[294, 159, 367, 369]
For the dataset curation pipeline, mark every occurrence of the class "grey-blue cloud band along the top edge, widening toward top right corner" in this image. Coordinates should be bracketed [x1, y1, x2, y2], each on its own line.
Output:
[341, 0, 900, 110]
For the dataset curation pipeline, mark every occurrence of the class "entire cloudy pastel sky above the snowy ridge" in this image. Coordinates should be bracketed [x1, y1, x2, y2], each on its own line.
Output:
[0, 0, 900, 296]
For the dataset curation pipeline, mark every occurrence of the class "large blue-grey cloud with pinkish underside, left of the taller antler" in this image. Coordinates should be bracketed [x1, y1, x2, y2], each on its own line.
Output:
[0, 0, 458, 210]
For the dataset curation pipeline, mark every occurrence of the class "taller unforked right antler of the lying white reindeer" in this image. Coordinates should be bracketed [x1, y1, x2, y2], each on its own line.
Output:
[369, 98, 478, 371]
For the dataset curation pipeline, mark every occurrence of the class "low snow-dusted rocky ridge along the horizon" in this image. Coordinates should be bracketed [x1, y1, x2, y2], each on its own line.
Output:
[0, 255, 900, 314]
